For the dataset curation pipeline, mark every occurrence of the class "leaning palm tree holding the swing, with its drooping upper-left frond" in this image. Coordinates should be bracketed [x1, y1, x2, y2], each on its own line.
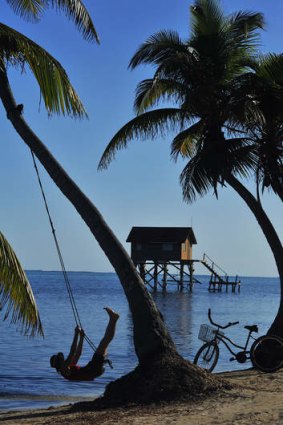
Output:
[0, 0, 221, 403]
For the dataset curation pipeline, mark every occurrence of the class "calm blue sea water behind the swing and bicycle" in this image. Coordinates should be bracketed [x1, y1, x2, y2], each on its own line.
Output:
[0, 271, 280, 410]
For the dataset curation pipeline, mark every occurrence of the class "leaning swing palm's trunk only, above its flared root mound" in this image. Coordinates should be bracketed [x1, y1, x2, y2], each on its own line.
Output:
[0, 69, 176, 363]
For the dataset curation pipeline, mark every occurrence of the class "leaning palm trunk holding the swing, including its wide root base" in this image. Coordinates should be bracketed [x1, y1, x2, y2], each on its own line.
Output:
[0, 66, 226, 406]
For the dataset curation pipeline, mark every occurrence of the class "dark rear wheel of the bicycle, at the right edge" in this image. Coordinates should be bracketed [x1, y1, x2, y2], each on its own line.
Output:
[250, 335, 283, 372]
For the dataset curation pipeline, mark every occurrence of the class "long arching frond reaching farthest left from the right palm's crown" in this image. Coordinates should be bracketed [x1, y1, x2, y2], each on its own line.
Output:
[98, 108, 188, 169]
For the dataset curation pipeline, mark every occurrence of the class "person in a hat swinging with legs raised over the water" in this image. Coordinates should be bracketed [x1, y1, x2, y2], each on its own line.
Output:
[50, 307, 119, 381]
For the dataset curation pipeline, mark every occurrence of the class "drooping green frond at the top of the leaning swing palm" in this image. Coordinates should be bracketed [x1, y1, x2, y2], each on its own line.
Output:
[0, 23, 86, 118]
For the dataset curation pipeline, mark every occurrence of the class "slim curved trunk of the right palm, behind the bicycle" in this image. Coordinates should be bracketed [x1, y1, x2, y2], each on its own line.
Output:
[225, 176, 283, 338]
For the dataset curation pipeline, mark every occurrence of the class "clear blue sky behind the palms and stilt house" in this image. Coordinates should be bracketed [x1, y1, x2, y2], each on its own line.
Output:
[0, 0, 283, 276]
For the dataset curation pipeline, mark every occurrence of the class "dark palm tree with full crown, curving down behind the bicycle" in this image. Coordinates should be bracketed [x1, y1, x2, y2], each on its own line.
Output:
[99, 0, 283, 336]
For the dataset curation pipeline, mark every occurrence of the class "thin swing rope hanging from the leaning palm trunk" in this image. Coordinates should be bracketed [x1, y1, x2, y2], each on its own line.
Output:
[31, 150, 97, 351]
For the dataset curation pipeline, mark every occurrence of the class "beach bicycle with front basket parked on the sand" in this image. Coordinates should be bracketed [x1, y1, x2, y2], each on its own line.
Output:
[193, 309, 283, 372]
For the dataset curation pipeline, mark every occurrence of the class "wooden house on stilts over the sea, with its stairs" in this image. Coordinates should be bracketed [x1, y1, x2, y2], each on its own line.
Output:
[127, 227, 240, 292]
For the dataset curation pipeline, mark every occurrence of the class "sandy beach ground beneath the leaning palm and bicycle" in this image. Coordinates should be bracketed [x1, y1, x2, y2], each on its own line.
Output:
[0, 370, 283, 425]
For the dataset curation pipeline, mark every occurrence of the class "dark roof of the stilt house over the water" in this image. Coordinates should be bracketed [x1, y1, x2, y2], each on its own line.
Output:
[127, 227, 197, 244]
